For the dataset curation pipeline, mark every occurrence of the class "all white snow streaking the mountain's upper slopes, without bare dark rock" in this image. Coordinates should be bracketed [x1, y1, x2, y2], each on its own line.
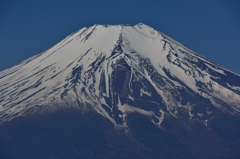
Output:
[0, 23, 240, 126]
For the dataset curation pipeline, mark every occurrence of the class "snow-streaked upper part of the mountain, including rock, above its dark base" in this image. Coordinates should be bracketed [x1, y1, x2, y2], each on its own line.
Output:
[0, 24, 240, 127]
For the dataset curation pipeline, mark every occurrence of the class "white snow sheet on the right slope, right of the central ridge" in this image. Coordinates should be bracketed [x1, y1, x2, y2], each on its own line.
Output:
[123, 24, 240, 111]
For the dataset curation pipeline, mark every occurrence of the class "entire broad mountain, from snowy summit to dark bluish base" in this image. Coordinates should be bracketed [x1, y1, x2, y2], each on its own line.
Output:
[0, 23, 240, 159]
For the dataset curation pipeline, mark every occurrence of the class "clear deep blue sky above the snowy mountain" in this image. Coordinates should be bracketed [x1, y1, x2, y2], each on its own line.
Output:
[0, 0, 240, 74]
